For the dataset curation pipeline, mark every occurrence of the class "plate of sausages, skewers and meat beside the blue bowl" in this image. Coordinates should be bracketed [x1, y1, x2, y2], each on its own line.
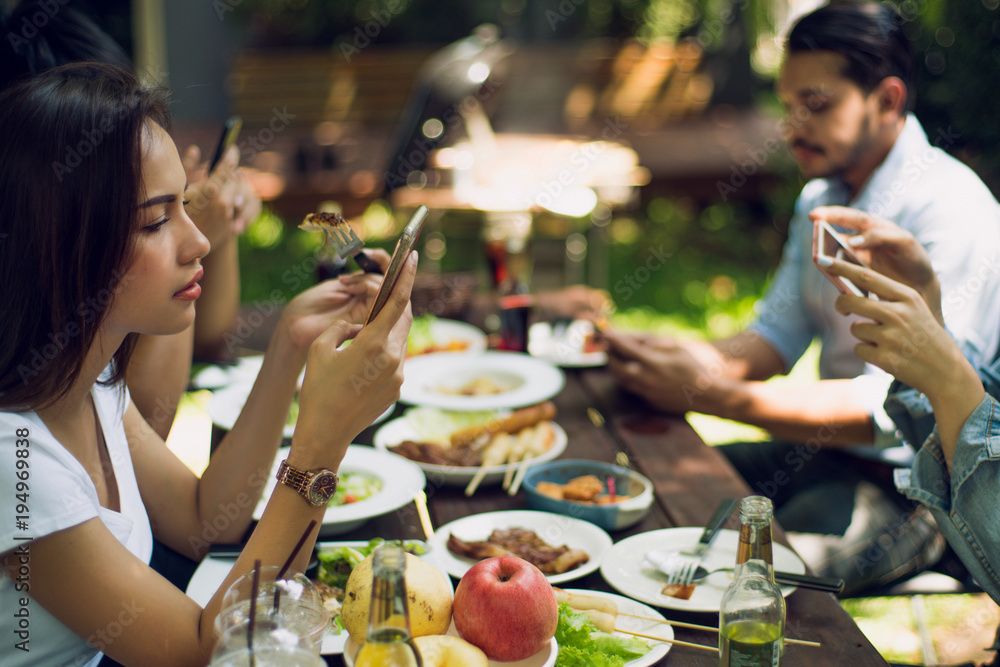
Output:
[374, 403, 567, 486]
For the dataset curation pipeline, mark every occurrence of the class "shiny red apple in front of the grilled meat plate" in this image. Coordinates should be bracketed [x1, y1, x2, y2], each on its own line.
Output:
[452, 556, 559, 662]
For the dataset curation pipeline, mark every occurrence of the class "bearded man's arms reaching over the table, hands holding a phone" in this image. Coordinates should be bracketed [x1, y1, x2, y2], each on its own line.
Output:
[604, 213, 873, 446]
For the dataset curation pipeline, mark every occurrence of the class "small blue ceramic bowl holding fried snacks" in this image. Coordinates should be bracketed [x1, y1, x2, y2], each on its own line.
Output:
[522, 459, 653, 530]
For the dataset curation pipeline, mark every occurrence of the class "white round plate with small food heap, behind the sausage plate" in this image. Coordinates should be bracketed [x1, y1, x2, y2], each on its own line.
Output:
[399, 352, 566, 410]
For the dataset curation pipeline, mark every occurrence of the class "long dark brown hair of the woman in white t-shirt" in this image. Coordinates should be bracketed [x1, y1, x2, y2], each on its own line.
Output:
[0, 63, 170, 410]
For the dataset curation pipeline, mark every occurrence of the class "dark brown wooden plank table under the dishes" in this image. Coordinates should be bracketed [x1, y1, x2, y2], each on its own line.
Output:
[327, 369, 887, 667]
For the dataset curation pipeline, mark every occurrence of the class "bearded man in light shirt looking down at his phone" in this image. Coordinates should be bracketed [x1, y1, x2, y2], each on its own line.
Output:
[607, 3, 1000, 594]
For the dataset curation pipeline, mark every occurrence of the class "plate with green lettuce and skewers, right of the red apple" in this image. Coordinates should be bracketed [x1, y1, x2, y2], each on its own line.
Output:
[554, 588, 674, 667]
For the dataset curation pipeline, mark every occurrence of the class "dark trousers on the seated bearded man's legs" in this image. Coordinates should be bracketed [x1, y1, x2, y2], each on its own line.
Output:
[720, 442, 945, 597]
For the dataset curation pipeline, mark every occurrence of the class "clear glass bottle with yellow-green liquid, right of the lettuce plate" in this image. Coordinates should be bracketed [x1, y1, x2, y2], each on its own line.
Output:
[719, 496, 785, 667]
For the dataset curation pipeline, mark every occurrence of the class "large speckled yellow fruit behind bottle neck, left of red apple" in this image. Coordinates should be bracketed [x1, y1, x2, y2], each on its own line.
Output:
[340, 554, 452, 645]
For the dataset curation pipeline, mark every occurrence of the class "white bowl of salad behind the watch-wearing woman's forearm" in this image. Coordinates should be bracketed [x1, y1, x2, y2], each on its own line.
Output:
[253, 445, 427, 536]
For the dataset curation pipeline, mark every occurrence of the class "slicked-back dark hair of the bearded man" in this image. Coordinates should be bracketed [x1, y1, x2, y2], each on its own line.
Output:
[786, 2, 915, 110]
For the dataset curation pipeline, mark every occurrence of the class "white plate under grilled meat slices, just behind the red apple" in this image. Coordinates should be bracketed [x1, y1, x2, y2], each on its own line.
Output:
[428, 510, 611, 584]
